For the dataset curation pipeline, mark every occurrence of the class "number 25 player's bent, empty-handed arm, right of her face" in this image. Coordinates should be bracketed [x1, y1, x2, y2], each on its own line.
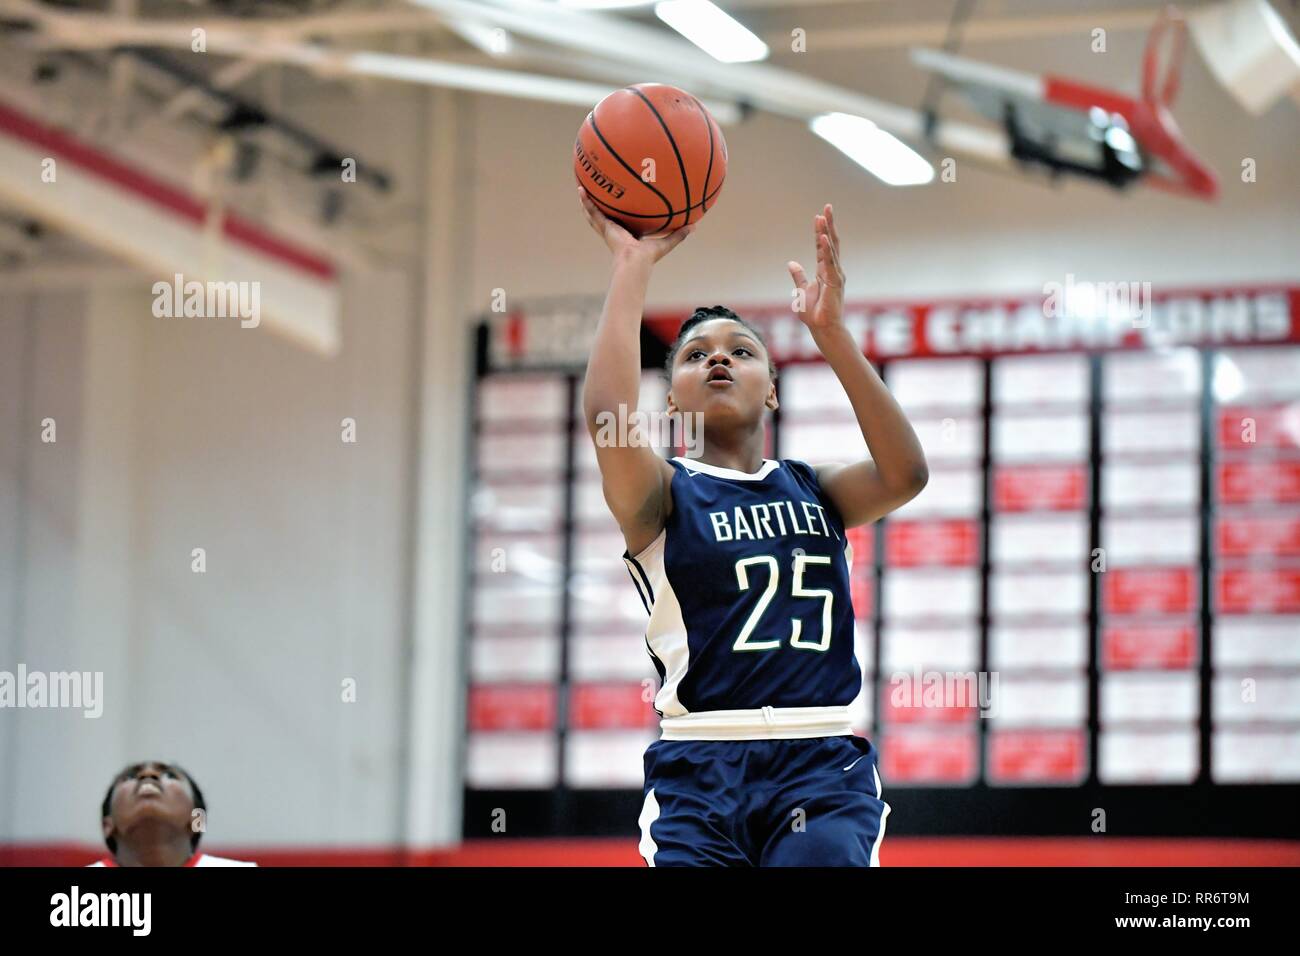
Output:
[789, 206, 930, 528]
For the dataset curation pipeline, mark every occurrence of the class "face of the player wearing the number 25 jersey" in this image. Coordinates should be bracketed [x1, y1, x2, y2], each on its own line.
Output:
[668, 319, 776, 428]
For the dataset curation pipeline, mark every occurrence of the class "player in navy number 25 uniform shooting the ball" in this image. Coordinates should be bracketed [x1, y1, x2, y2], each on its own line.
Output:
[579, 187, 928, 866]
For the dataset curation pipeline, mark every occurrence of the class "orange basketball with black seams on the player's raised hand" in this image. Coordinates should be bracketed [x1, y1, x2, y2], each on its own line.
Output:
[573, 83, 727, 235]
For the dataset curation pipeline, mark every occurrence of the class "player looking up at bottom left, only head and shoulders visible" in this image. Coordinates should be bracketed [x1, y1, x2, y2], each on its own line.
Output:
[91, 760, 257, 866]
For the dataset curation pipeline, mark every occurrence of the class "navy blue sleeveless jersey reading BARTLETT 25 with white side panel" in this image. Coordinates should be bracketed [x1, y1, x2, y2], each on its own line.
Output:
[624, 458, 862, 717]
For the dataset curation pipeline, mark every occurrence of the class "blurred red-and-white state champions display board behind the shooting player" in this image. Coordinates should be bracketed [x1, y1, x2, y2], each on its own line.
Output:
[464, 282, 1300, 836]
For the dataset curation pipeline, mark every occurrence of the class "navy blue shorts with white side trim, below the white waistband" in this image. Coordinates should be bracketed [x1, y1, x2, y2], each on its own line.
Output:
[640, 735, 889, 866]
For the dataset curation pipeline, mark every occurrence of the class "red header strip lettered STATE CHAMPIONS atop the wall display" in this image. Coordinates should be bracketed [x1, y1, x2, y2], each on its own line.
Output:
[488, 283, 1300, 371]
